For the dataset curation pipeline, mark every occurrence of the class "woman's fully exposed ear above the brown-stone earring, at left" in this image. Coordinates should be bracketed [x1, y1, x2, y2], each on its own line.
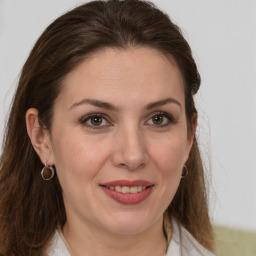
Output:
[26, 108, 54, 166]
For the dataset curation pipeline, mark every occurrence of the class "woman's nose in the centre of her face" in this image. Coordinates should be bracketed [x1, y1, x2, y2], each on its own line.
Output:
[112, 124, 149, 171]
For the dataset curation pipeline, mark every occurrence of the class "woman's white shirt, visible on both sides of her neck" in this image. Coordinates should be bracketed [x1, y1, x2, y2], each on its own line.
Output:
[47, 218, 213, 256]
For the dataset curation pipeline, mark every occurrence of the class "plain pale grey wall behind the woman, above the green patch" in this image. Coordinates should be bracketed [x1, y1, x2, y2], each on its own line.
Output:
[0, 0, 256, 230]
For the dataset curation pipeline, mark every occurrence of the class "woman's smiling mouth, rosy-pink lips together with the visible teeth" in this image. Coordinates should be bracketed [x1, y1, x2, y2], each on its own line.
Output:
[100, 180, 154, 205]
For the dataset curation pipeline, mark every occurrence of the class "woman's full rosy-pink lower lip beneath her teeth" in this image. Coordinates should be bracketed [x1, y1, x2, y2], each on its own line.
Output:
[101, 186, 153, 204]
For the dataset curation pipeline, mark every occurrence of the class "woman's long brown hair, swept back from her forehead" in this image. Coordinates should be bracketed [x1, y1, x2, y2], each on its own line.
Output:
[0, 0, 214, 256]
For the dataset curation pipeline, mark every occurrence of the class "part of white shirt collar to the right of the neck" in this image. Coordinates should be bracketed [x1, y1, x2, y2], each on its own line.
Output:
[166, 219, 214, 256]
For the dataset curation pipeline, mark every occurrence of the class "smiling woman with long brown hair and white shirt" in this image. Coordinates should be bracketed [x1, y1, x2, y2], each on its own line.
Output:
[0, 0, 214, 256]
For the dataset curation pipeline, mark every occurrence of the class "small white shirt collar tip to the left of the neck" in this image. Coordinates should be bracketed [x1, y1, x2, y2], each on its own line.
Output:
[46, 230, 71, 256]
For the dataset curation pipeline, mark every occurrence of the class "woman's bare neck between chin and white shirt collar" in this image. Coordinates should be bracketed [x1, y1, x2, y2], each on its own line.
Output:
[63, 216, 167, 256]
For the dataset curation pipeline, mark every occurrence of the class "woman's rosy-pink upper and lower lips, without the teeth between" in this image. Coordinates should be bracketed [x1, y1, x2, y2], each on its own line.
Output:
[100, 180, 154, 205]
